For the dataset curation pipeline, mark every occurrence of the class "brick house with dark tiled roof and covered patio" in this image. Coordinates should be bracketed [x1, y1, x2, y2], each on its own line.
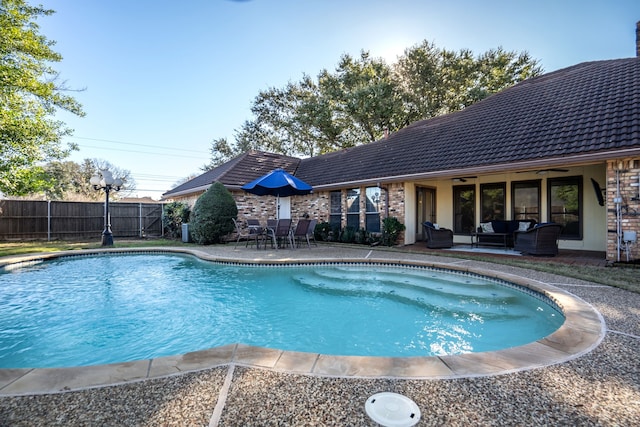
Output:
[164, 42, 640, 261]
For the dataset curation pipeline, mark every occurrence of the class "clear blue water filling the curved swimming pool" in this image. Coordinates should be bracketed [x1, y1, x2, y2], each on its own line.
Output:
[0, 254, 564, 368]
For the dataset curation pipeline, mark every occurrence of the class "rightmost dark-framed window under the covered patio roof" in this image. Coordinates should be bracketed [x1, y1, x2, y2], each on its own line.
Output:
[547, 177, 582, 239]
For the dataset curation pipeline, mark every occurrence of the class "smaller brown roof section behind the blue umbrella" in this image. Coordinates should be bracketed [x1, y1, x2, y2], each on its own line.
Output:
[162, 150, 300, 198]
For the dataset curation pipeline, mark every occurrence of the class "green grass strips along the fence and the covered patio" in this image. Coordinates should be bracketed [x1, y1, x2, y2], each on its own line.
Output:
[0, 239, 640, 293]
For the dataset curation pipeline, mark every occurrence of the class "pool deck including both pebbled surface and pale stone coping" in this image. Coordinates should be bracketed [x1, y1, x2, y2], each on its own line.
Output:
[0, 245, 640, 425]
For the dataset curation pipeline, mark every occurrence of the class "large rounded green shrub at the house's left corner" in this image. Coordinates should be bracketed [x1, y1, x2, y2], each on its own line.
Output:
[189, 182, 238, 245]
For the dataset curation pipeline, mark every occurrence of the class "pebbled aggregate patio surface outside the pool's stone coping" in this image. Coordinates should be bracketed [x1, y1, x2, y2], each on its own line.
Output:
[0, 245, 640, 426]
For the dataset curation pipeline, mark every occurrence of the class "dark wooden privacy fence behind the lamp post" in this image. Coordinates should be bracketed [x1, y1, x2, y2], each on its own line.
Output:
[0, 200, 163, 240]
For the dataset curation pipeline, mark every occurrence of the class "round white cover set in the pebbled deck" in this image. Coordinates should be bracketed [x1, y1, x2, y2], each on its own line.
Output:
[364, 392, 420, 427]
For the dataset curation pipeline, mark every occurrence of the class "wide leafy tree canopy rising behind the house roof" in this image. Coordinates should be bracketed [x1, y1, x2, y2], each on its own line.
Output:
[204, 41, 542, 165]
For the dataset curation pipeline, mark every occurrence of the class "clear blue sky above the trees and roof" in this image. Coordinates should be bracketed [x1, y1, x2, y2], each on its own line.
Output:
[41, 0, 640, 199]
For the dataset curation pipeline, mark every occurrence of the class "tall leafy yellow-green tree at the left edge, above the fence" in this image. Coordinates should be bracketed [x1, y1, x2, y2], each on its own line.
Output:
[0, 0, 84, 195]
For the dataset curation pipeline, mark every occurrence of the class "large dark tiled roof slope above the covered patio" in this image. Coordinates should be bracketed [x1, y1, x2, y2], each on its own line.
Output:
[296, 58, 640, 186]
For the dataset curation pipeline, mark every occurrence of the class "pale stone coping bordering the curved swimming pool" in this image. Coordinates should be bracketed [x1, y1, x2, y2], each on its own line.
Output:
[0, 247, 606, 396]
